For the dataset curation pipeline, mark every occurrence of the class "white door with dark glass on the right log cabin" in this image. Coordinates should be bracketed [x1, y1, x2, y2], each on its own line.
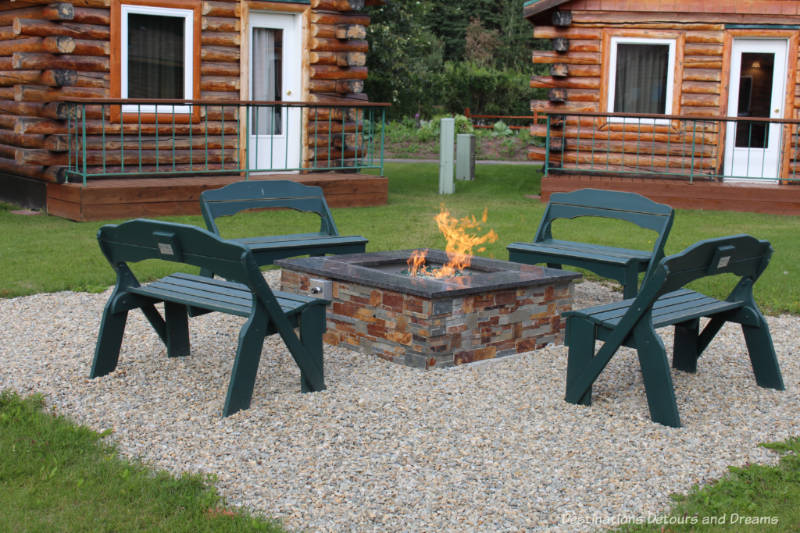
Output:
[725, 39, 788, 181]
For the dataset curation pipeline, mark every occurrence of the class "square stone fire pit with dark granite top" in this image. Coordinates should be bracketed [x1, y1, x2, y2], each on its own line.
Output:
[276, 250, 580, 368]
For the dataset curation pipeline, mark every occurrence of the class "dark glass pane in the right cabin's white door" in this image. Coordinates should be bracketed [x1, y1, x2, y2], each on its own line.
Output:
[736, 52, 775, 148]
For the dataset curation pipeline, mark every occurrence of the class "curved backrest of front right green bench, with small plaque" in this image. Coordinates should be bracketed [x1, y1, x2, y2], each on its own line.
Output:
[640, 235, 772, 300]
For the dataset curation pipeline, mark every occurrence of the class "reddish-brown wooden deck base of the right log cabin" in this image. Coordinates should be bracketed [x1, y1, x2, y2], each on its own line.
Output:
[541, 174, 800, 215]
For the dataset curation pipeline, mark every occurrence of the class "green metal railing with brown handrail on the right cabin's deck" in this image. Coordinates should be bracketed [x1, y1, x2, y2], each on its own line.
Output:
[539, 112, 800, 182]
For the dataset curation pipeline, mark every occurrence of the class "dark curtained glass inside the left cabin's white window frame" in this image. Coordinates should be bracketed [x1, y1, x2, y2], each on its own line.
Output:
[127, 13, 186, 99]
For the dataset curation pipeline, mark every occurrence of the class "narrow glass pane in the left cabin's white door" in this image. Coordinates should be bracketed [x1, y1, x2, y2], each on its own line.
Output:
[251, 28, 283, 135]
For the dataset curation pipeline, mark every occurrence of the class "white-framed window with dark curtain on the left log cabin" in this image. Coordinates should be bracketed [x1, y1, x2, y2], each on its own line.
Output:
[119, 5, 195, 113]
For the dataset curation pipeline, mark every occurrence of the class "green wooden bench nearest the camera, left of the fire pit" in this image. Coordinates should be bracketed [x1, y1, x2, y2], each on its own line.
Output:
[90, 219, 328, 416]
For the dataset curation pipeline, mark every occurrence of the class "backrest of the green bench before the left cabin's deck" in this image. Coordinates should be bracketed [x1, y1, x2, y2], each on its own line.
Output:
[200, 180, 339, 235]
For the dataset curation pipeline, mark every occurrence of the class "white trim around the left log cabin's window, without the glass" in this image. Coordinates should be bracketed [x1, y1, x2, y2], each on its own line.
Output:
[120, 4, 194, 113]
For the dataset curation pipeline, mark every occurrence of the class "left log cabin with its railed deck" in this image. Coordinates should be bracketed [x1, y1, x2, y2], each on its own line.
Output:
[0, 0, 387, 220]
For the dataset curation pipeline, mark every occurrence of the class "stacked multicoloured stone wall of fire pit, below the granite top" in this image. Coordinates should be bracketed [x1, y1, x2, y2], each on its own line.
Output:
[281, 251, 575, 368]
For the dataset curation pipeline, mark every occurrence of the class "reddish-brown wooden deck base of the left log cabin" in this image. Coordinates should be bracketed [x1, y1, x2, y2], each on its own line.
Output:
[47, 173, 389, 221]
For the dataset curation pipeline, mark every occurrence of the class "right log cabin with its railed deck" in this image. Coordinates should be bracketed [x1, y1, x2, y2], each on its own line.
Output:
[523, 0, 800, 214]
